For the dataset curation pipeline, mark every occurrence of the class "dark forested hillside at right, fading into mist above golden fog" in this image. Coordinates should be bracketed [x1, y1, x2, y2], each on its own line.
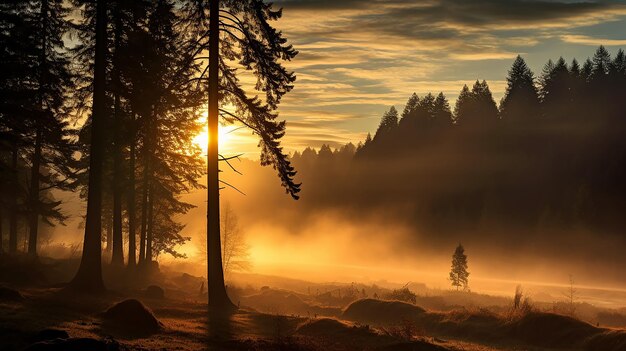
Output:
[292, 46, 626, 235]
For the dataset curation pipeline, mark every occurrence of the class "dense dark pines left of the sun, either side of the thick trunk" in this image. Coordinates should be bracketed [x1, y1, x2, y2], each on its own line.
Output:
[0, 1, 204, 266]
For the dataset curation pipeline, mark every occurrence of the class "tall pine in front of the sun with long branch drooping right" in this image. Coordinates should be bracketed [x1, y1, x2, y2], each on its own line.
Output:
[183, 0, 300, 311]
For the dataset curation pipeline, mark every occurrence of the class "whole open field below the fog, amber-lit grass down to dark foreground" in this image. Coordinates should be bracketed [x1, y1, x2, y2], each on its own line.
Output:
[0, 260, 626, 351]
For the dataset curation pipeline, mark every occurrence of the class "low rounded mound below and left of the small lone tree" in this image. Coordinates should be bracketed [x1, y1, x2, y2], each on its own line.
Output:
[342, 299, 425, 324]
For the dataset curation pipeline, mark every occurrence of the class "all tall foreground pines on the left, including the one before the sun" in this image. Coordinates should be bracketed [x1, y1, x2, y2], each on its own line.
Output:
[0, 0, 299, 307]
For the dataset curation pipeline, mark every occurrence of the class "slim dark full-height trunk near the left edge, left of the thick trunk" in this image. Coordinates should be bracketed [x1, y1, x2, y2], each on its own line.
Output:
[28, 0, 48, 257]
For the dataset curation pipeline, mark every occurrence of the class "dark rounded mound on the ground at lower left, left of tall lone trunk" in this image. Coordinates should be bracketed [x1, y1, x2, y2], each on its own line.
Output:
[102, 299, 161, 335]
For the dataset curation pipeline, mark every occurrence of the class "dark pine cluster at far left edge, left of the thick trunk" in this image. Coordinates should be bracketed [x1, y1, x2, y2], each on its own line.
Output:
[0, 0, 74, 257]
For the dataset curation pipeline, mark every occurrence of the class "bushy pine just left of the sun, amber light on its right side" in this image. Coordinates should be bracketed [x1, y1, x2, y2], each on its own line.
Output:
[130, 0, 204, 264]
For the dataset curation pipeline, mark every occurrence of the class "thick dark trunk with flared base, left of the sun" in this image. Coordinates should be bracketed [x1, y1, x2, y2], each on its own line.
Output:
[71, 0, 107, 292]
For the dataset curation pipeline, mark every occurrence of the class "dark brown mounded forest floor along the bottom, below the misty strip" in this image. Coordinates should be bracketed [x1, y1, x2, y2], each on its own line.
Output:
[0, 258, 626, 351]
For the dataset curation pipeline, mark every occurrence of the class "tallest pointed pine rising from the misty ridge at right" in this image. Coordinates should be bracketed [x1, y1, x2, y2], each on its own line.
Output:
[500, 56, 539, 123]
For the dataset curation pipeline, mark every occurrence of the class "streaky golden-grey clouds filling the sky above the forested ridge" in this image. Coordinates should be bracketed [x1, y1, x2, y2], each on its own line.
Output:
[227, 0, 626, 154]
